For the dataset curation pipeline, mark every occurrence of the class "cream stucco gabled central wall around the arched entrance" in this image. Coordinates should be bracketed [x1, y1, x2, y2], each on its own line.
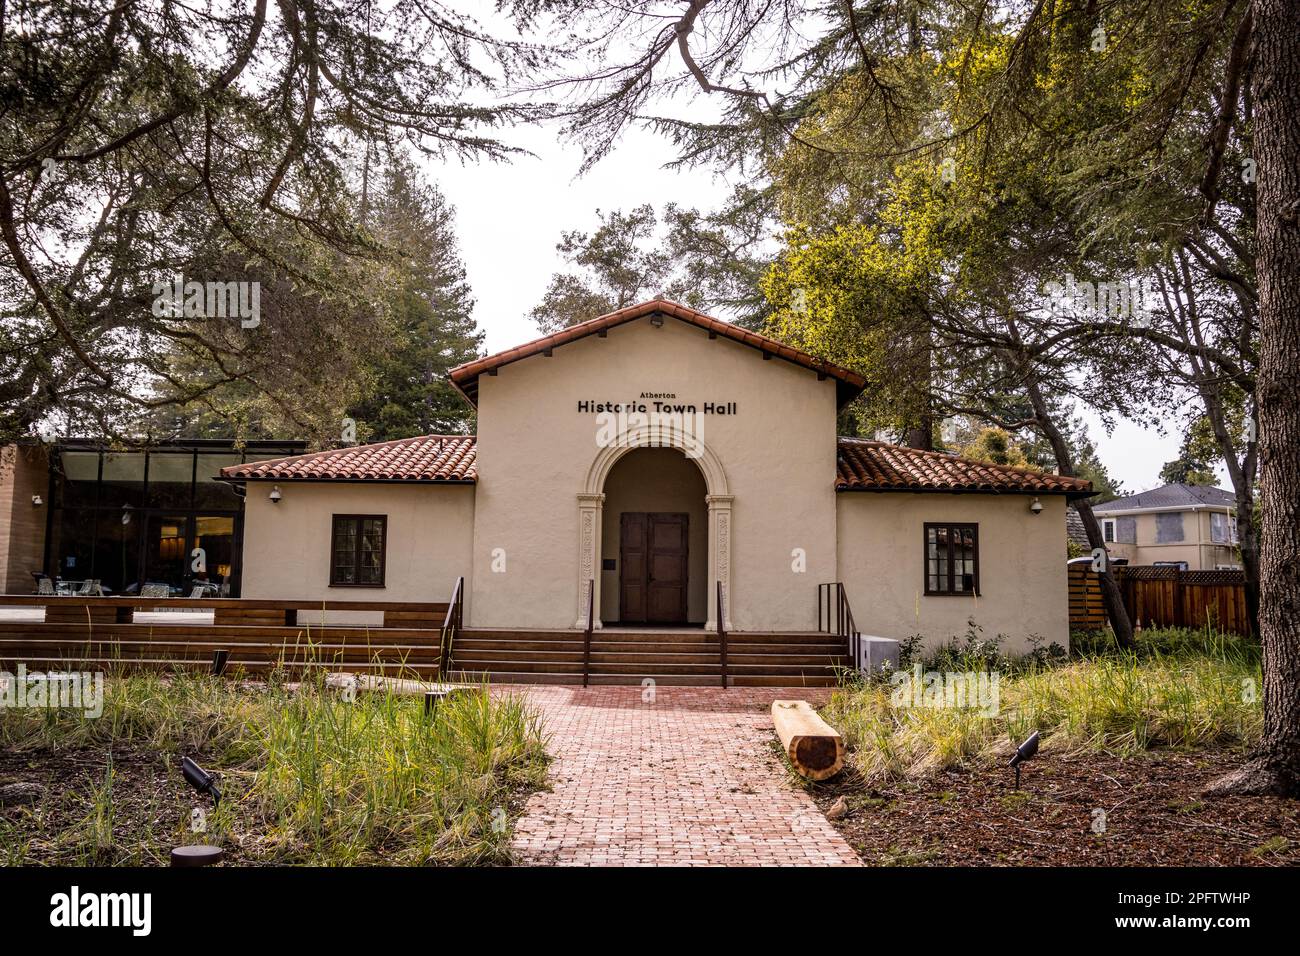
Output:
[467, 317, 836, 630]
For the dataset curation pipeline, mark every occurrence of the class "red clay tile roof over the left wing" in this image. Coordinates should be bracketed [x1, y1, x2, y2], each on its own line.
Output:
[221, 434, 478, 483]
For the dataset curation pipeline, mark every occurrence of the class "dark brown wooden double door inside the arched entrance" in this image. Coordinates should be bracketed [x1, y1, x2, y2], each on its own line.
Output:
[619, 511, 690, 624]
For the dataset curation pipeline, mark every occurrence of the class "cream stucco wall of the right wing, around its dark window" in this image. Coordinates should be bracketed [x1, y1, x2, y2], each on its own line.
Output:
[839, 492, 1070, 653]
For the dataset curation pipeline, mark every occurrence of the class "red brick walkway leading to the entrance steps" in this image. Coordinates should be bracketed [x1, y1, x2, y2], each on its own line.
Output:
[510, 685, 858, 866]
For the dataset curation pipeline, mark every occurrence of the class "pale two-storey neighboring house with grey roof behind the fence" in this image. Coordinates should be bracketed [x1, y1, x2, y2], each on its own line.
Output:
[1092, 484, 1242, 571]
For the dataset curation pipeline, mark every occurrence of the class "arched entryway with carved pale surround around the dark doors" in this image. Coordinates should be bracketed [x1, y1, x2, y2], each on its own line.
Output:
[576, 429, 732, 630]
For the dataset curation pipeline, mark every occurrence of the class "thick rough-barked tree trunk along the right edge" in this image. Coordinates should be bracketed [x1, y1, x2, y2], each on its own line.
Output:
[1209, 0, 1300, 796]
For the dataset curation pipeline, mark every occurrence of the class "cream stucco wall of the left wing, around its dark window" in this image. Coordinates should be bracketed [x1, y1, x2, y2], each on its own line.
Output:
[242, 481, 475, 623]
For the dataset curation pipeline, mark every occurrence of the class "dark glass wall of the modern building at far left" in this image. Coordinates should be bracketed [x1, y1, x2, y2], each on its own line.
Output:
[46, 441, 306, 597]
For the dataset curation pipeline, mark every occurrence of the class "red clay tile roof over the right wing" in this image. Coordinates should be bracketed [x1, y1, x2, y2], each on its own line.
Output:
[835, 438, 1092, 498]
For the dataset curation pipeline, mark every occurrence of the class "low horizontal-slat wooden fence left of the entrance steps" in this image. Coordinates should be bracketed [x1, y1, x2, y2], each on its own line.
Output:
[0, 594, 447, 678]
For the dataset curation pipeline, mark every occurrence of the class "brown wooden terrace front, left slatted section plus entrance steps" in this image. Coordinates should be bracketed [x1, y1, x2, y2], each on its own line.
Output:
[0, 594, 849, 687]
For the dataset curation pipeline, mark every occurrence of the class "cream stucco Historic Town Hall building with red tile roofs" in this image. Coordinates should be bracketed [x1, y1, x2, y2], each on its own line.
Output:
[222, 300, 1092, 650]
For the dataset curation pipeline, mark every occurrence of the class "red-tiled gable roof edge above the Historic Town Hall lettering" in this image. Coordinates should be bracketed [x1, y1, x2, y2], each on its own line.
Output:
[447, 299, 867, 407]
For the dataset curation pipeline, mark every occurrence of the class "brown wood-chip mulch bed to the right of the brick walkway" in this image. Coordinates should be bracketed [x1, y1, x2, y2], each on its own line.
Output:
[813, 752, 1300, 866]
